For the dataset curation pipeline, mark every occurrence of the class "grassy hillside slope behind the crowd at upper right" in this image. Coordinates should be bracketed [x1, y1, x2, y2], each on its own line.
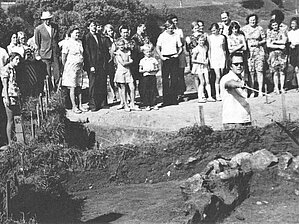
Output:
[150, 0, 296, 35]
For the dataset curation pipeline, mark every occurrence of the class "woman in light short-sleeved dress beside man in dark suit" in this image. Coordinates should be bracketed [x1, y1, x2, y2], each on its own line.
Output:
[61, 27, 88, 114]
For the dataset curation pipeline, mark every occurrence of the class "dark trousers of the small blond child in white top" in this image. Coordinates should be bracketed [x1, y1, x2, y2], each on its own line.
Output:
[142, 75, 157, 107]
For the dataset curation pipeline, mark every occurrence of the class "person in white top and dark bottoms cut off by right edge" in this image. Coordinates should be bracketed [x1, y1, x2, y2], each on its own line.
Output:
[288, 17, 299, 92]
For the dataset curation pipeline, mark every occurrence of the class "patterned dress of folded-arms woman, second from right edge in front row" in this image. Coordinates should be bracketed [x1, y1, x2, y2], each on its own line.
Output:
[267, 30, 287, 72]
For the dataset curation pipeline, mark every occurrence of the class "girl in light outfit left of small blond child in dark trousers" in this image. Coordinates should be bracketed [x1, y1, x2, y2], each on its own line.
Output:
[114, 39, 140, 112]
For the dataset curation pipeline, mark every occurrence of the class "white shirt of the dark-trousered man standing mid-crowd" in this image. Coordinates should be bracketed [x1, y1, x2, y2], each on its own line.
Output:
[157, 31, 182, 56]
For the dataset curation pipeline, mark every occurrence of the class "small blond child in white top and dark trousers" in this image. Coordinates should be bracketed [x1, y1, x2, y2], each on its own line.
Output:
[139, 45, 159, 111]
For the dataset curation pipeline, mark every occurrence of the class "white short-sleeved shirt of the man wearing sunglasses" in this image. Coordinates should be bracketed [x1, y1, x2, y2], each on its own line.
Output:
[220, 71, 251, 124]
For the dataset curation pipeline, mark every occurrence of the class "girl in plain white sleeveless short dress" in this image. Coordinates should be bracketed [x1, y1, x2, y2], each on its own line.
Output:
[208, 23, 226, 101]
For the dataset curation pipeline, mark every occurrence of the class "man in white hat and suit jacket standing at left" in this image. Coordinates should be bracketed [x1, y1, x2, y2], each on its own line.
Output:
[34, 11, 60, 89]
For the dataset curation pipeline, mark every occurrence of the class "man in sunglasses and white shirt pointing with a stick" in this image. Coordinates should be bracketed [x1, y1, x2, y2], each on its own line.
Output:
[220, 53, 251, 129]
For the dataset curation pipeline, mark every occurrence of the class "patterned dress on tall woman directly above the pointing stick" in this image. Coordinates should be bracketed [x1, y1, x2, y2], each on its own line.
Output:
[242, 24, 266, 72]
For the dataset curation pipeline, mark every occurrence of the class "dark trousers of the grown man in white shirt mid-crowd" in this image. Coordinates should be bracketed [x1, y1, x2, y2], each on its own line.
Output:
[162, 58, 179, 106]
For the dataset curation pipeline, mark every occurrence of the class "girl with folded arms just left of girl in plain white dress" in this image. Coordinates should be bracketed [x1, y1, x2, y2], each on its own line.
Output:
[192, 35, 215, 103]
